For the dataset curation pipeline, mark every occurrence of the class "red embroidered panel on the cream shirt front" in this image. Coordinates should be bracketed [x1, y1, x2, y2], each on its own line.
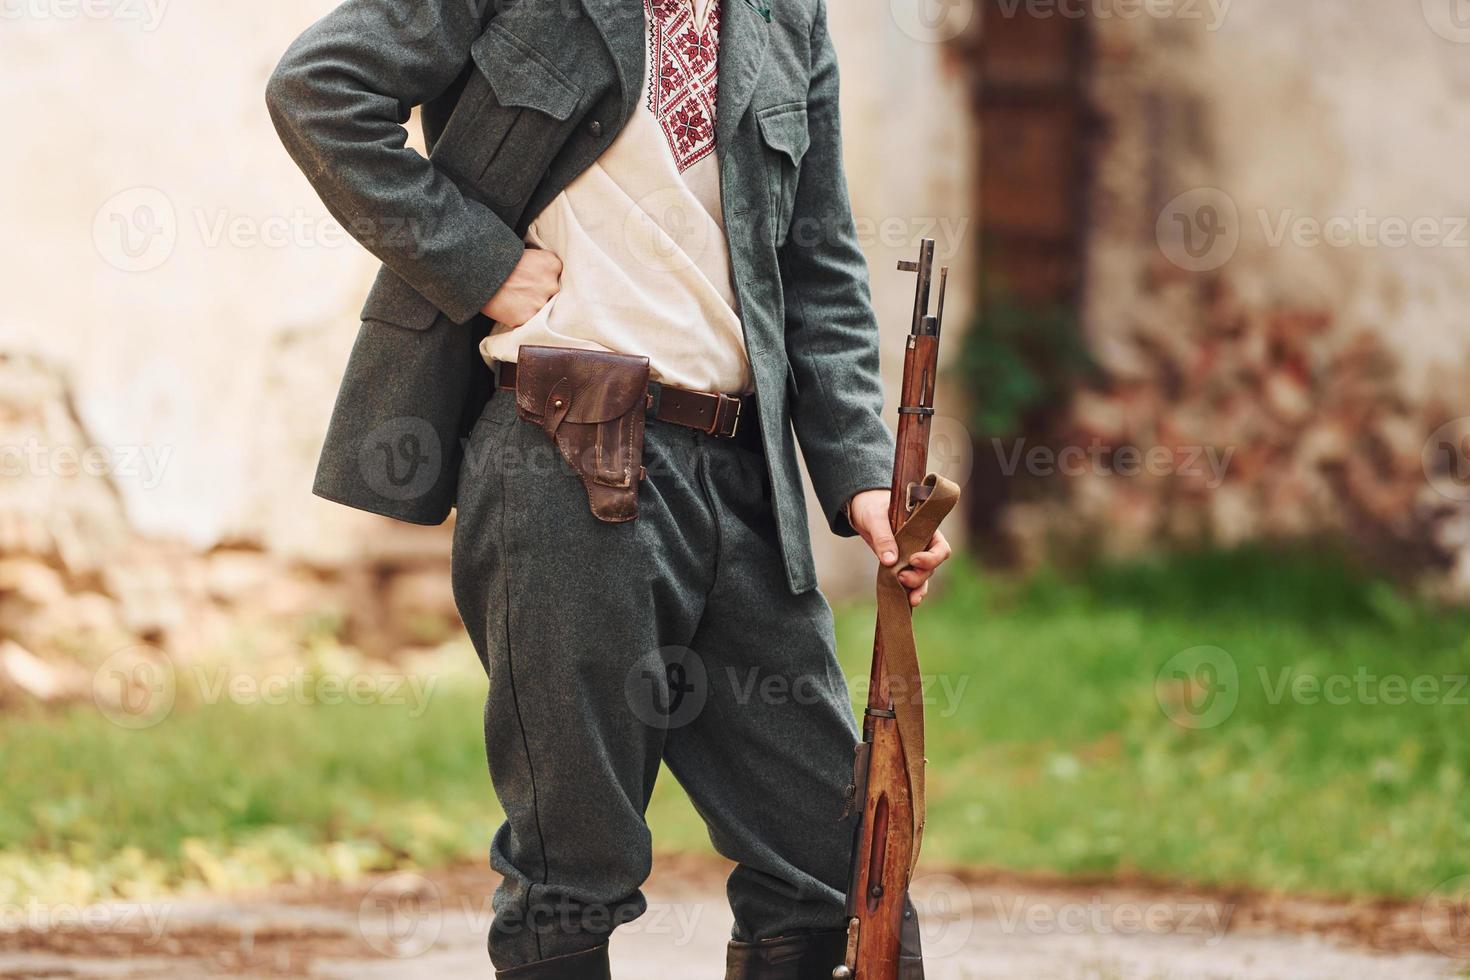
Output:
[644, 0, 720, 173]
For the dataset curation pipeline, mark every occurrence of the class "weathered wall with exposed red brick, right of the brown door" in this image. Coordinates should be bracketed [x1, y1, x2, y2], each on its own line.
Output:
[1010, 0, 1470, 591]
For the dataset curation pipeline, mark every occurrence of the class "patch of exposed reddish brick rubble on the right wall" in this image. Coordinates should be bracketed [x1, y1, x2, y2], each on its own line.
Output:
[1005, 282, 1470, 597]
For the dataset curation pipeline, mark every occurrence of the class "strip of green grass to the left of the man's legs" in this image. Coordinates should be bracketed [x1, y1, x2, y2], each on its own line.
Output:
[0, 675, 498, 901]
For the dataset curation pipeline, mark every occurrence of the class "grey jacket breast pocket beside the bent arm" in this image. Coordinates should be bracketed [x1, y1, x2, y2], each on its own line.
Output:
[434, 22, 582, 207]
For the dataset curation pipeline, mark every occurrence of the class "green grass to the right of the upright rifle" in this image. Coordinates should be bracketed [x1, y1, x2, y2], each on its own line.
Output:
[882, 551, 1470, 895]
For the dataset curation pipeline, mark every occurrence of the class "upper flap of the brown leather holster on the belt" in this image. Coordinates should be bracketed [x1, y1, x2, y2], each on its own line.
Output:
[516, 344, 648, 423]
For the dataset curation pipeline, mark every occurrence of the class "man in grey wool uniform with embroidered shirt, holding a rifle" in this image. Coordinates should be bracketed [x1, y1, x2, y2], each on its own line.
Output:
[268, 0, 950, 980]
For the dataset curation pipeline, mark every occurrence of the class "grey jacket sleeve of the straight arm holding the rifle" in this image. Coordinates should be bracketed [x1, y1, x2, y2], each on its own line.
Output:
[781, 0, 894, 536]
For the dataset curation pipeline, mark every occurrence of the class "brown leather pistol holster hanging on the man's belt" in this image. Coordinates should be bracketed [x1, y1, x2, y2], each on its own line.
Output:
[516, 345, 648, 523]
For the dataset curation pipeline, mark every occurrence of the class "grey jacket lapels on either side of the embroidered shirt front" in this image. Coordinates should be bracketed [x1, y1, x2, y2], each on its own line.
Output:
[582, 0, 772, 151]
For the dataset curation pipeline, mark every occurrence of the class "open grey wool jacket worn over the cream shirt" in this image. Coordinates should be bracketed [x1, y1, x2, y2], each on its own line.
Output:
[266, 0, 892, 592]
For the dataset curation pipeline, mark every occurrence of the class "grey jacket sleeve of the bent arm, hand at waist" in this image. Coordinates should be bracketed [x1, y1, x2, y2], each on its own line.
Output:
[266, 0, 525, 323]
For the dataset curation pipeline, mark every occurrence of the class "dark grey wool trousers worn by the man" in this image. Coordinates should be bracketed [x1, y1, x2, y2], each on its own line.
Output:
[454, 392, 858, 970]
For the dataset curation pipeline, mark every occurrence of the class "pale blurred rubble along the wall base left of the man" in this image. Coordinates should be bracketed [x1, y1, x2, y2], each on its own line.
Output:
[0, 356, 459, 708]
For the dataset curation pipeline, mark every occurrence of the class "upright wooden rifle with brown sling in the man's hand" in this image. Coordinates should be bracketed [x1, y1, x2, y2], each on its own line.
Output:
[832, 238, 960, 980]
